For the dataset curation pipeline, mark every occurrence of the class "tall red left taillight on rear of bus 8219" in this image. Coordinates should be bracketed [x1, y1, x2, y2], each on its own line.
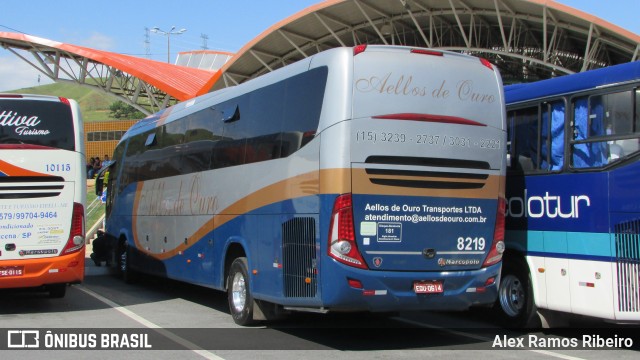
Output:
[328, 194, 367, 269]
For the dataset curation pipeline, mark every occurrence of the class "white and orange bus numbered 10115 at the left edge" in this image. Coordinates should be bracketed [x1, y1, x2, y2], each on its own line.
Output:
[0, 94, 87, 298]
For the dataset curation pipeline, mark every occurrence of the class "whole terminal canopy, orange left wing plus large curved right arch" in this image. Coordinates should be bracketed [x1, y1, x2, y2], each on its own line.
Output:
[0, 0, 640, 113]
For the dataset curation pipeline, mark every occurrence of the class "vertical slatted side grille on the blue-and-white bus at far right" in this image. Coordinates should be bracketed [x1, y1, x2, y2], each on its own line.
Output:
[615, 219, 640, 313]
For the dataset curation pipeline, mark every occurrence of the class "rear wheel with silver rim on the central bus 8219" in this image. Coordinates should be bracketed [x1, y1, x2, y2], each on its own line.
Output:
[227, 257, 254, 326]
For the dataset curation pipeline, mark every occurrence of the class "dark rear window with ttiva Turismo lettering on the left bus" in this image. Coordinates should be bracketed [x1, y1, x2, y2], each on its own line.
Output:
[0, 99, 75, 151]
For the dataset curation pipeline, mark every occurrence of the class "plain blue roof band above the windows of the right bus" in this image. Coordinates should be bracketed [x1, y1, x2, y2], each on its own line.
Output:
[504, 61, 640, 105]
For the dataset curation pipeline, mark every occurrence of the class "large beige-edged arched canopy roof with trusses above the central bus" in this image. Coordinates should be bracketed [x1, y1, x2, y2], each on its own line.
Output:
[212, 0, 640, 90]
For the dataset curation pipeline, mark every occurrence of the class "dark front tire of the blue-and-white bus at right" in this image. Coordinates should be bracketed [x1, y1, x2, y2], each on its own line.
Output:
[495, 261, 541, 328]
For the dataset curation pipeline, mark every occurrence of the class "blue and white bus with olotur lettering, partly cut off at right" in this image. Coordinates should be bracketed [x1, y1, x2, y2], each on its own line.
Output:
[499, 62, 640, 326]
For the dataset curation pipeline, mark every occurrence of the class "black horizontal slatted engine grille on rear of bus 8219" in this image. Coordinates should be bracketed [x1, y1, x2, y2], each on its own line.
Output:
[365, 156, 490, 190]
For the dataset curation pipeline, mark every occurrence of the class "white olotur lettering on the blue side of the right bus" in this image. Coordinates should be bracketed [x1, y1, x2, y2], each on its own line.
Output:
[507, 189, 591, 219]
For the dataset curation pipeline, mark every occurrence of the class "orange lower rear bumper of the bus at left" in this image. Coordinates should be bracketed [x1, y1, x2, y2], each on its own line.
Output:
[0, 248, 85, 289]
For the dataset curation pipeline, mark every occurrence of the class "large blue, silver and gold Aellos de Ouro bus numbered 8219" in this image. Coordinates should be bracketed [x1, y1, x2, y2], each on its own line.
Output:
[106, 46, 506, 324]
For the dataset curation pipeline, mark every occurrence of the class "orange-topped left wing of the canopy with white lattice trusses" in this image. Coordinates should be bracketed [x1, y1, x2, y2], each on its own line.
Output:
[0, 32, 215, 114]
